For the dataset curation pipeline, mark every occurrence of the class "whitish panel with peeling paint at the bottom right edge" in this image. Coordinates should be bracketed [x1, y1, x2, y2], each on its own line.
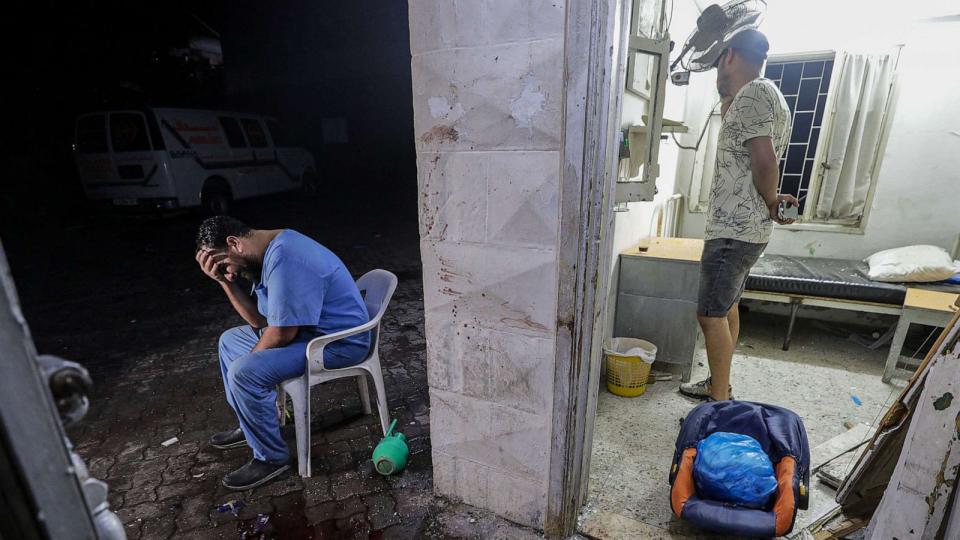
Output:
[867, 330, 960, 539]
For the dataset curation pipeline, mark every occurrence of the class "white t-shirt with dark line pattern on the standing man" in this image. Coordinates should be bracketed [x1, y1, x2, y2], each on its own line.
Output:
[705, 78, 790, 244]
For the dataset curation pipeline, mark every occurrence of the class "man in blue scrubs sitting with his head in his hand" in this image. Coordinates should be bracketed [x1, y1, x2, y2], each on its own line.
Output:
[196, 216, 370, 490]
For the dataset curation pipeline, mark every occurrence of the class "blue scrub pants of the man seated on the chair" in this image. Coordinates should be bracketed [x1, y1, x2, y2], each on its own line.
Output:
[220, 326, 367, 463]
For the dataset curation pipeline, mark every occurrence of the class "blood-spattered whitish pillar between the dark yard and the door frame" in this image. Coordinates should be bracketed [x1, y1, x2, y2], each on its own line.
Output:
[410, 0, 565, 528]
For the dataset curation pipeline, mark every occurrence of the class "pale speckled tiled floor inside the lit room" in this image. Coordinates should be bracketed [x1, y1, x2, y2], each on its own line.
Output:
[581, 314, 903, 538]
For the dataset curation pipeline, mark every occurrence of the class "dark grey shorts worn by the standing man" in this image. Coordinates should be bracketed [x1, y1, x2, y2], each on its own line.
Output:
[697, 238, 767, 317]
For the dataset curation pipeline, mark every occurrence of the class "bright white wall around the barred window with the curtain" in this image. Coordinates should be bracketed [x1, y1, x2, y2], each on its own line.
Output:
[676, 0, 960, 258]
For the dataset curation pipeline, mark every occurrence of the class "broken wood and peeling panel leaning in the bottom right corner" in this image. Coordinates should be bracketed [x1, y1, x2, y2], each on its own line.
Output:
[808, 313, 960, 539]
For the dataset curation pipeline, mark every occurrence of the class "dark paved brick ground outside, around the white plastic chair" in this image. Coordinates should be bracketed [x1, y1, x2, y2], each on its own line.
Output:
[5, 196, 537, 539]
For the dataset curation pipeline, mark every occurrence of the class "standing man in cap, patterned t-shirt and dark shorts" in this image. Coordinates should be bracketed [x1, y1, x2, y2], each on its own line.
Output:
[680, 29, 799, 401]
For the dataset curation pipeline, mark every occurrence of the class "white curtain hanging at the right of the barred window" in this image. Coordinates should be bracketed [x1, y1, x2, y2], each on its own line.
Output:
[816, 53, 895, 221]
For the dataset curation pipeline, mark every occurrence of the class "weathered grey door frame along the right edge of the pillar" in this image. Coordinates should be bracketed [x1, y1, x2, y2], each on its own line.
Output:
[544, 0, 631, 537]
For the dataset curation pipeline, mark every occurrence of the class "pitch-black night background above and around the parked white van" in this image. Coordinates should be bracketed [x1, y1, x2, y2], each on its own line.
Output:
[0, 0, 416, 234]
